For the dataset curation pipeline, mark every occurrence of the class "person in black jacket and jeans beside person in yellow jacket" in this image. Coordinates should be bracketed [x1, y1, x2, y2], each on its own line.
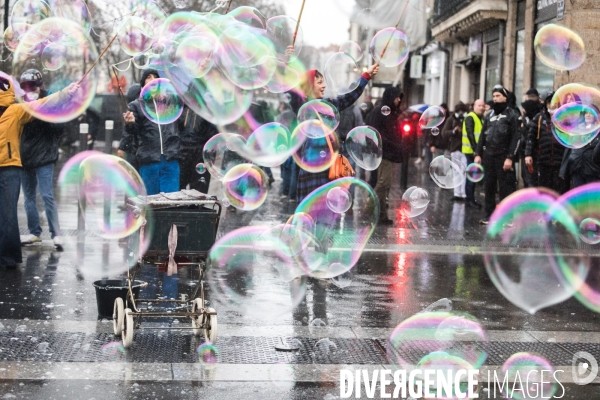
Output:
[20, 70, 63, 251]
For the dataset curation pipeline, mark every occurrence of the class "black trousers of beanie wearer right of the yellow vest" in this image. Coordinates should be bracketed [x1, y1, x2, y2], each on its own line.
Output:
[483, 156, 517, 218]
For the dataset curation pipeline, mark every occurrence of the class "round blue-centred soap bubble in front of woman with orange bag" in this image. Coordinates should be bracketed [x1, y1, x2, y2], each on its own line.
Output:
[292, 124, 340, 173]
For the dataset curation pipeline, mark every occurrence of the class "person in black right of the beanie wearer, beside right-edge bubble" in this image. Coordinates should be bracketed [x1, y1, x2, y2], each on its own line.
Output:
[523, 93, 568, 194]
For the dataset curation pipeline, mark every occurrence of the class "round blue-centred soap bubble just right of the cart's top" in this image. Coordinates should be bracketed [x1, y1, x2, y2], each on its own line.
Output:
[223, 164, 269, 211]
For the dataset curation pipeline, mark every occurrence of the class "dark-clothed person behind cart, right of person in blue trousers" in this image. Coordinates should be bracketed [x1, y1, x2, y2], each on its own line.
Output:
[178, 106, 219, 193]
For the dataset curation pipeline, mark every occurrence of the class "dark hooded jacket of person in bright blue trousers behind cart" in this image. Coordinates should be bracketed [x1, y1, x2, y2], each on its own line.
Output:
[125, 70, 180, 166]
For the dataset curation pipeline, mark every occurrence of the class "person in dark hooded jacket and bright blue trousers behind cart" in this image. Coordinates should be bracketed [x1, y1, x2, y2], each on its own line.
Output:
[124, 69, 179, 195]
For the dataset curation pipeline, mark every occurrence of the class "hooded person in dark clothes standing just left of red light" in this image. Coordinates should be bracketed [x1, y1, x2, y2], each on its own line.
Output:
[366, 86, 404, 225]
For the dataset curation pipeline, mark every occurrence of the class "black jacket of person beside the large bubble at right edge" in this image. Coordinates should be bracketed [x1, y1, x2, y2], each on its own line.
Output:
[525, 112, 565, 167]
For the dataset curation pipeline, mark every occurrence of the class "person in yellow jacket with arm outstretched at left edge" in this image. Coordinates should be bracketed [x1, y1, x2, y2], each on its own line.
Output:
[0, 74, 79, 269]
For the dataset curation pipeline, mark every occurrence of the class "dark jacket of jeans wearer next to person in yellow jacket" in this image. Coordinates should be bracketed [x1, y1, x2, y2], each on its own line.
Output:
[21, 90, 63, 169]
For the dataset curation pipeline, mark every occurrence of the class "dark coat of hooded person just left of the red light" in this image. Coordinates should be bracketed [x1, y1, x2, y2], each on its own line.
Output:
[366, 88, 402, 163]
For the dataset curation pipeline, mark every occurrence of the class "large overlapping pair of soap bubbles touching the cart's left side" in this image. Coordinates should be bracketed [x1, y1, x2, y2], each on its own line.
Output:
[58, 151, 153, 276]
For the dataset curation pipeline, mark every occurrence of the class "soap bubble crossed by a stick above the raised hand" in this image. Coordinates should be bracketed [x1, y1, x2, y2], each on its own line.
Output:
[369, 28, 409, 67]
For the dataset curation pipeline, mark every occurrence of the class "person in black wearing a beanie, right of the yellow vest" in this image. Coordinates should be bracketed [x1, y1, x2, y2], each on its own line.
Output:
[475, 85, 521, 225]
